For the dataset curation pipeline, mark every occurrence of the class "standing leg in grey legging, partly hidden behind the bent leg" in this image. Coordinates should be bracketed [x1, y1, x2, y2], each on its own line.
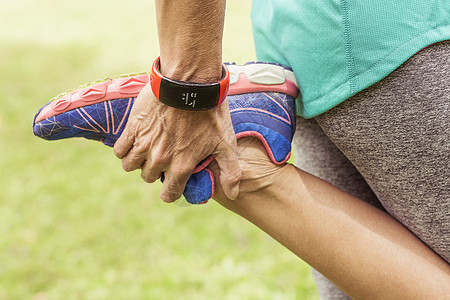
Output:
[293, 117, 383, 300]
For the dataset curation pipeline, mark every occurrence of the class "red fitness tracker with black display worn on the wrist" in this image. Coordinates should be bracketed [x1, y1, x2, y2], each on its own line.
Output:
[150, 57, 230, 111]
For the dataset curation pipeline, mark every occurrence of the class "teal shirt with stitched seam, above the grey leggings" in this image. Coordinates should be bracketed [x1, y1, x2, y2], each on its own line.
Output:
[252, 0, 450, 118]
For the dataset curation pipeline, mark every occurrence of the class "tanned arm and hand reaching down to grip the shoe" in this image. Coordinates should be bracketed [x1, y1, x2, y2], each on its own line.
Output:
[114, 0, 241, 202]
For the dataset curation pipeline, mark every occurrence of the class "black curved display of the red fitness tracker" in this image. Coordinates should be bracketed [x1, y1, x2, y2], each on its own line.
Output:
[159, 77, 220, 110]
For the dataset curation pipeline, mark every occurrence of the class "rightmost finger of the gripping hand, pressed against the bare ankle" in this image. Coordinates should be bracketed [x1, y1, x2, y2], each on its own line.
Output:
[214, 143, 242, 200]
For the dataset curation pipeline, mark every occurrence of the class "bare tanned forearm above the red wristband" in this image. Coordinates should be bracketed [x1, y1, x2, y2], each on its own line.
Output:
[156, 0, 225, 82]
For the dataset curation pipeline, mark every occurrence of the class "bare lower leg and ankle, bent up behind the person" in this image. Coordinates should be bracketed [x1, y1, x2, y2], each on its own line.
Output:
[214, 139, 450, 299]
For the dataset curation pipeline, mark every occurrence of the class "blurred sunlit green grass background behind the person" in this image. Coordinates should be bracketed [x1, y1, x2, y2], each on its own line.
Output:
[0, 0, 317, 300]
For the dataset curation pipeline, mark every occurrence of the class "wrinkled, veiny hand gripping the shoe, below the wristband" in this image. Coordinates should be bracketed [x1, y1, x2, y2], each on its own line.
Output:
[114, 85, 241, 202]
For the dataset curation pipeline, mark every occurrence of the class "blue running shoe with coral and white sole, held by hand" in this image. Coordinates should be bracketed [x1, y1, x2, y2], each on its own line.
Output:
[33, 62, 298, 204]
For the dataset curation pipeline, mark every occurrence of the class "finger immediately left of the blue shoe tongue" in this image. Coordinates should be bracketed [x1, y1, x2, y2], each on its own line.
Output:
[160, 162, 195, 203]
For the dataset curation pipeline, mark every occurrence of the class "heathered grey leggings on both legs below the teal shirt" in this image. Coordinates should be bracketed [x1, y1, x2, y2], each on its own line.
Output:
[294, 41, 450, 299]
